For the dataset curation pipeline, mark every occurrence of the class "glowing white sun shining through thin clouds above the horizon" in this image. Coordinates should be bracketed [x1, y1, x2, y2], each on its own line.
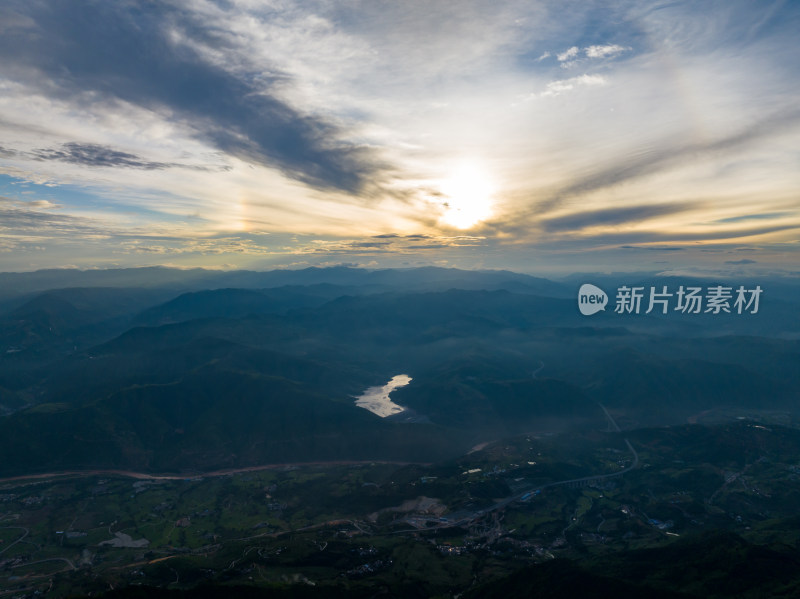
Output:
[440, 164, 493, 229]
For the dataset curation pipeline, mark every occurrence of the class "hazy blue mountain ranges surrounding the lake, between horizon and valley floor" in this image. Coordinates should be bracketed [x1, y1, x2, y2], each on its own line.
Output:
[0, 267, 800, 473]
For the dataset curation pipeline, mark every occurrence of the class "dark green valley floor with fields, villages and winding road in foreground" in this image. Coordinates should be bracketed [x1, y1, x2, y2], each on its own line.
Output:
[0, 421, 800, 597]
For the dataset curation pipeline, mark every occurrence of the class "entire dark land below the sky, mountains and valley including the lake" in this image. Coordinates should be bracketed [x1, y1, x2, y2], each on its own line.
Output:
[0, 269, 800, 597]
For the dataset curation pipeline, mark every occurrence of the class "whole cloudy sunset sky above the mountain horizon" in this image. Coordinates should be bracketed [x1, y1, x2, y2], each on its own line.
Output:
[0, 0, 800, 276]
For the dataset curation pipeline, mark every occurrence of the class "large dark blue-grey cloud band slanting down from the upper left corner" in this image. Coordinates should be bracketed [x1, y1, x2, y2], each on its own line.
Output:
[0, 2, 381, 192]
